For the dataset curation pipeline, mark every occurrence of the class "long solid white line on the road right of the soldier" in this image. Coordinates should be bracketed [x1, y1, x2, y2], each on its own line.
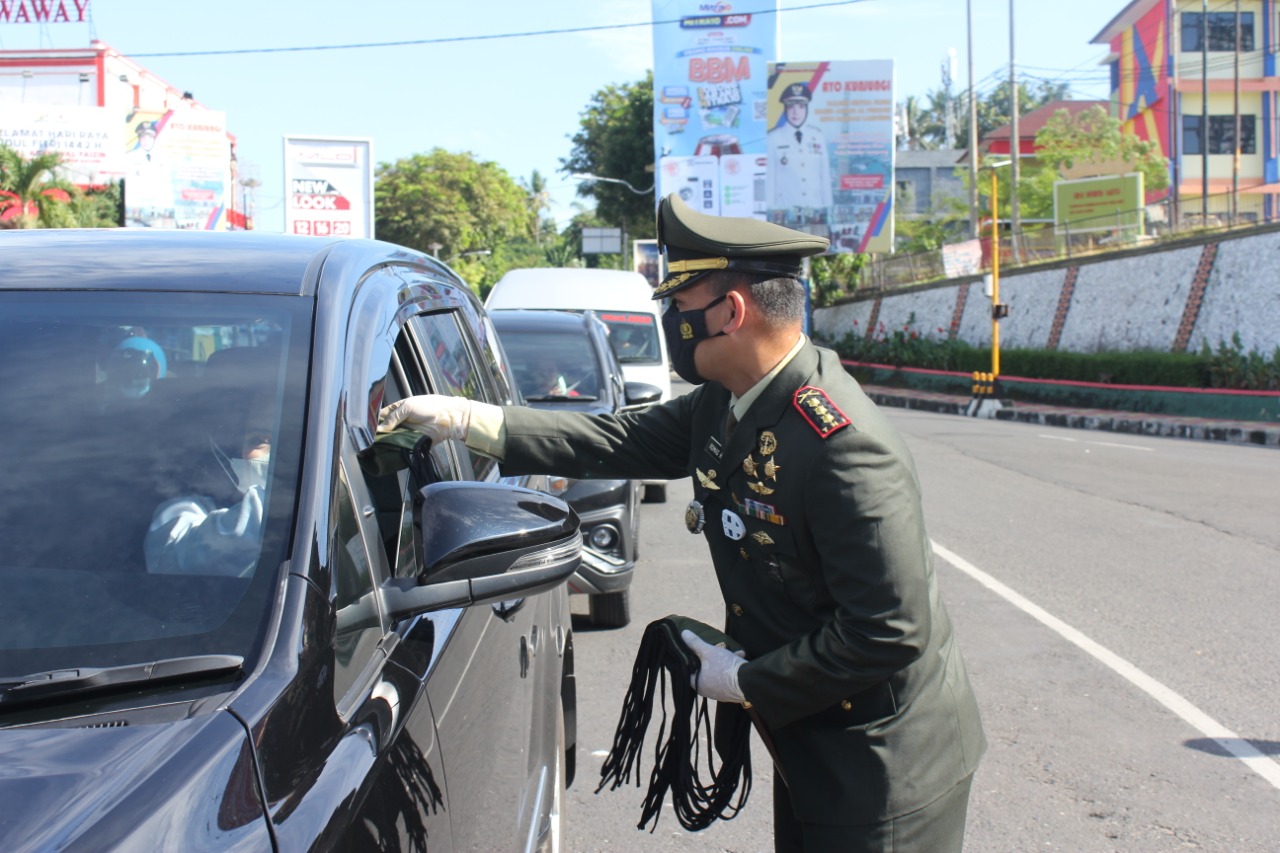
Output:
[932, 542, 1280, 789]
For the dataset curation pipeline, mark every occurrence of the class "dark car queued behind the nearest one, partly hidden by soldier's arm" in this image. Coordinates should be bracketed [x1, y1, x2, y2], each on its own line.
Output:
[489, 310, 662, 628]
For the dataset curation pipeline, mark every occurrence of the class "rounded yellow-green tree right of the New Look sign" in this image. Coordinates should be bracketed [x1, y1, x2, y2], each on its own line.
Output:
[374, 149, 536, 261]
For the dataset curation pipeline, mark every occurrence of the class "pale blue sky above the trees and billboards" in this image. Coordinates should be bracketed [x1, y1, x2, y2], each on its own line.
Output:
[0, 0, 1124, 231]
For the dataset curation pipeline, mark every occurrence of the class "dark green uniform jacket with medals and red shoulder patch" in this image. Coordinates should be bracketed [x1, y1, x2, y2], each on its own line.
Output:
[503, 343, 986, 825]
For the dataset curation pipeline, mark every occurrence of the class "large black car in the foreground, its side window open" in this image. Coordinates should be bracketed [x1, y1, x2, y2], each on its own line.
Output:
[0, 229, 581, 853]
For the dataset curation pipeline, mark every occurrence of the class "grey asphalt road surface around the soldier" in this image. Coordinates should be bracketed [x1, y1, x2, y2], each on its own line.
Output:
[566, 399, 1280, 853]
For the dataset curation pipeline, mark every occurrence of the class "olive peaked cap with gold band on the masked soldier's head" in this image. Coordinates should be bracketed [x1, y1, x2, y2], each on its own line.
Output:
[653, 193, 831, 300]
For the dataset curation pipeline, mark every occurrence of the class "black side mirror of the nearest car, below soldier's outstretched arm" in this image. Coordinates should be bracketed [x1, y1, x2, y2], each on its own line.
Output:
[383, 482, 582, 620]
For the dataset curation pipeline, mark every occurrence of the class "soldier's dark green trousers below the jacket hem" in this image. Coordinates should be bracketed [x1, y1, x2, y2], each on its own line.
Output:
[773, 775, 973, 853]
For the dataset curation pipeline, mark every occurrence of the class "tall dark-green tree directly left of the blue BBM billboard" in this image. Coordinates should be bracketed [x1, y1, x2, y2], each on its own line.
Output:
[561, 72, 655, 240]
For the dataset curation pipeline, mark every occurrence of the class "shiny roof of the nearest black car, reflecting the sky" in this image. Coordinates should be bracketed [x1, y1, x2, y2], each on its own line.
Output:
[0, 228, 350, 295]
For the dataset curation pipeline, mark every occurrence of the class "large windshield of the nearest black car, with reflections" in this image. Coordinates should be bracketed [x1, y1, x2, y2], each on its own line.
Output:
[0, 291, 311, 678]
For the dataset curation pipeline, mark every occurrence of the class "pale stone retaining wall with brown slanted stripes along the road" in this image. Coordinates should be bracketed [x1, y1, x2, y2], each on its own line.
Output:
[813, 224, 1280, 355]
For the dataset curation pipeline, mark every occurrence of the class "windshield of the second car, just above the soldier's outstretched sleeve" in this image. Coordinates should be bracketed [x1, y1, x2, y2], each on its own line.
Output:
[499, 327, 602, 402]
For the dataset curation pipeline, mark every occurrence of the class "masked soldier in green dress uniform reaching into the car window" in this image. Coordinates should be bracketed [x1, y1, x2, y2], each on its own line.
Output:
[381, 196, 986, 853]
